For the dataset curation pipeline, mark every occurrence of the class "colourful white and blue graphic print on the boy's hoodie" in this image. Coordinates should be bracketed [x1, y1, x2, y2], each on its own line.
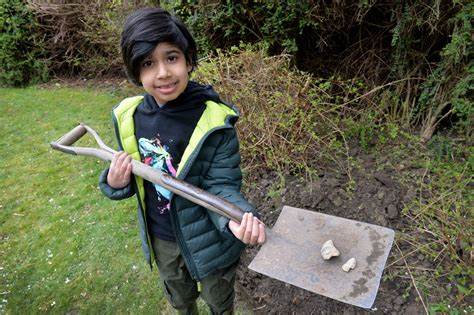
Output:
[138, 135, 176, 214]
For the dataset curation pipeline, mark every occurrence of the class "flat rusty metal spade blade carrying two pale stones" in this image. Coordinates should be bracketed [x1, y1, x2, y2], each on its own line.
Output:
[249, 206, 395, 308]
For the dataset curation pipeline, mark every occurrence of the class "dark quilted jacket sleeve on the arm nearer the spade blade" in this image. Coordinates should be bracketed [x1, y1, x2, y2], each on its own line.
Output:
[203, 129, 258, 237]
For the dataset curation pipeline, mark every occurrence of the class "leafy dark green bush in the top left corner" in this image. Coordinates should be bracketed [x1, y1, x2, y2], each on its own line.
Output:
[0, 0, 48, 86]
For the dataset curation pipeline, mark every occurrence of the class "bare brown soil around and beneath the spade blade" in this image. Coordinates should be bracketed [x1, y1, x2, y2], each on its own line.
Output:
[237, 154, 429, 314]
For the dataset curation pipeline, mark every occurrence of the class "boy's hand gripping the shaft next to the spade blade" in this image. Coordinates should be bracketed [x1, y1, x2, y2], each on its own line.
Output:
[229, 212, 265, 245]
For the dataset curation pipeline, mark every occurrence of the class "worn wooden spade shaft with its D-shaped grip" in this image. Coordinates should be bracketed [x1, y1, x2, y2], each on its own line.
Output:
[51, 123, 244, 223]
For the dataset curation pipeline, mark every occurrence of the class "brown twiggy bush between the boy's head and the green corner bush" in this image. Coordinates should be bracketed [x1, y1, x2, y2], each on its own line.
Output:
[28, 0, 134, 77]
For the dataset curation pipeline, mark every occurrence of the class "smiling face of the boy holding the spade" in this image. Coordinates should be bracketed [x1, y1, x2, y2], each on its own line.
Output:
[140, 43, 192, 104]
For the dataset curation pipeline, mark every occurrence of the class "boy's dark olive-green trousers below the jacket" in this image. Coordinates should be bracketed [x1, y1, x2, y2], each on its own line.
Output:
[152, 237, 237, 314]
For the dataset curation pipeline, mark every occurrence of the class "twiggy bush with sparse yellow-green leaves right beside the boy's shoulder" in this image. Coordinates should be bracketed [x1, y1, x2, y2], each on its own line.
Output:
[191, 46, 363, 178]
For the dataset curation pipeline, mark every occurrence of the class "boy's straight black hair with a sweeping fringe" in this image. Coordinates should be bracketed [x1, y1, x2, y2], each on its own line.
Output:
[120, 8, 197, 86]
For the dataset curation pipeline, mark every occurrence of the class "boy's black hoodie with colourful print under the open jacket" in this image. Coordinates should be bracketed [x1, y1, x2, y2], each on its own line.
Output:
[134, 81, 221, 241]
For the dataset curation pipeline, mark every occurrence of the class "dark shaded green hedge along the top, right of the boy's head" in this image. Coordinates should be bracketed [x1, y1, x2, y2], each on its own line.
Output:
[170, 0, 474, 140]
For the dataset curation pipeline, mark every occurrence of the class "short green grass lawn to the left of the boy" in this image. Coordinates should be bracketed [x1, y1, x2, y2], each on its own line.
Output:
[0, 87, 215, 314]
